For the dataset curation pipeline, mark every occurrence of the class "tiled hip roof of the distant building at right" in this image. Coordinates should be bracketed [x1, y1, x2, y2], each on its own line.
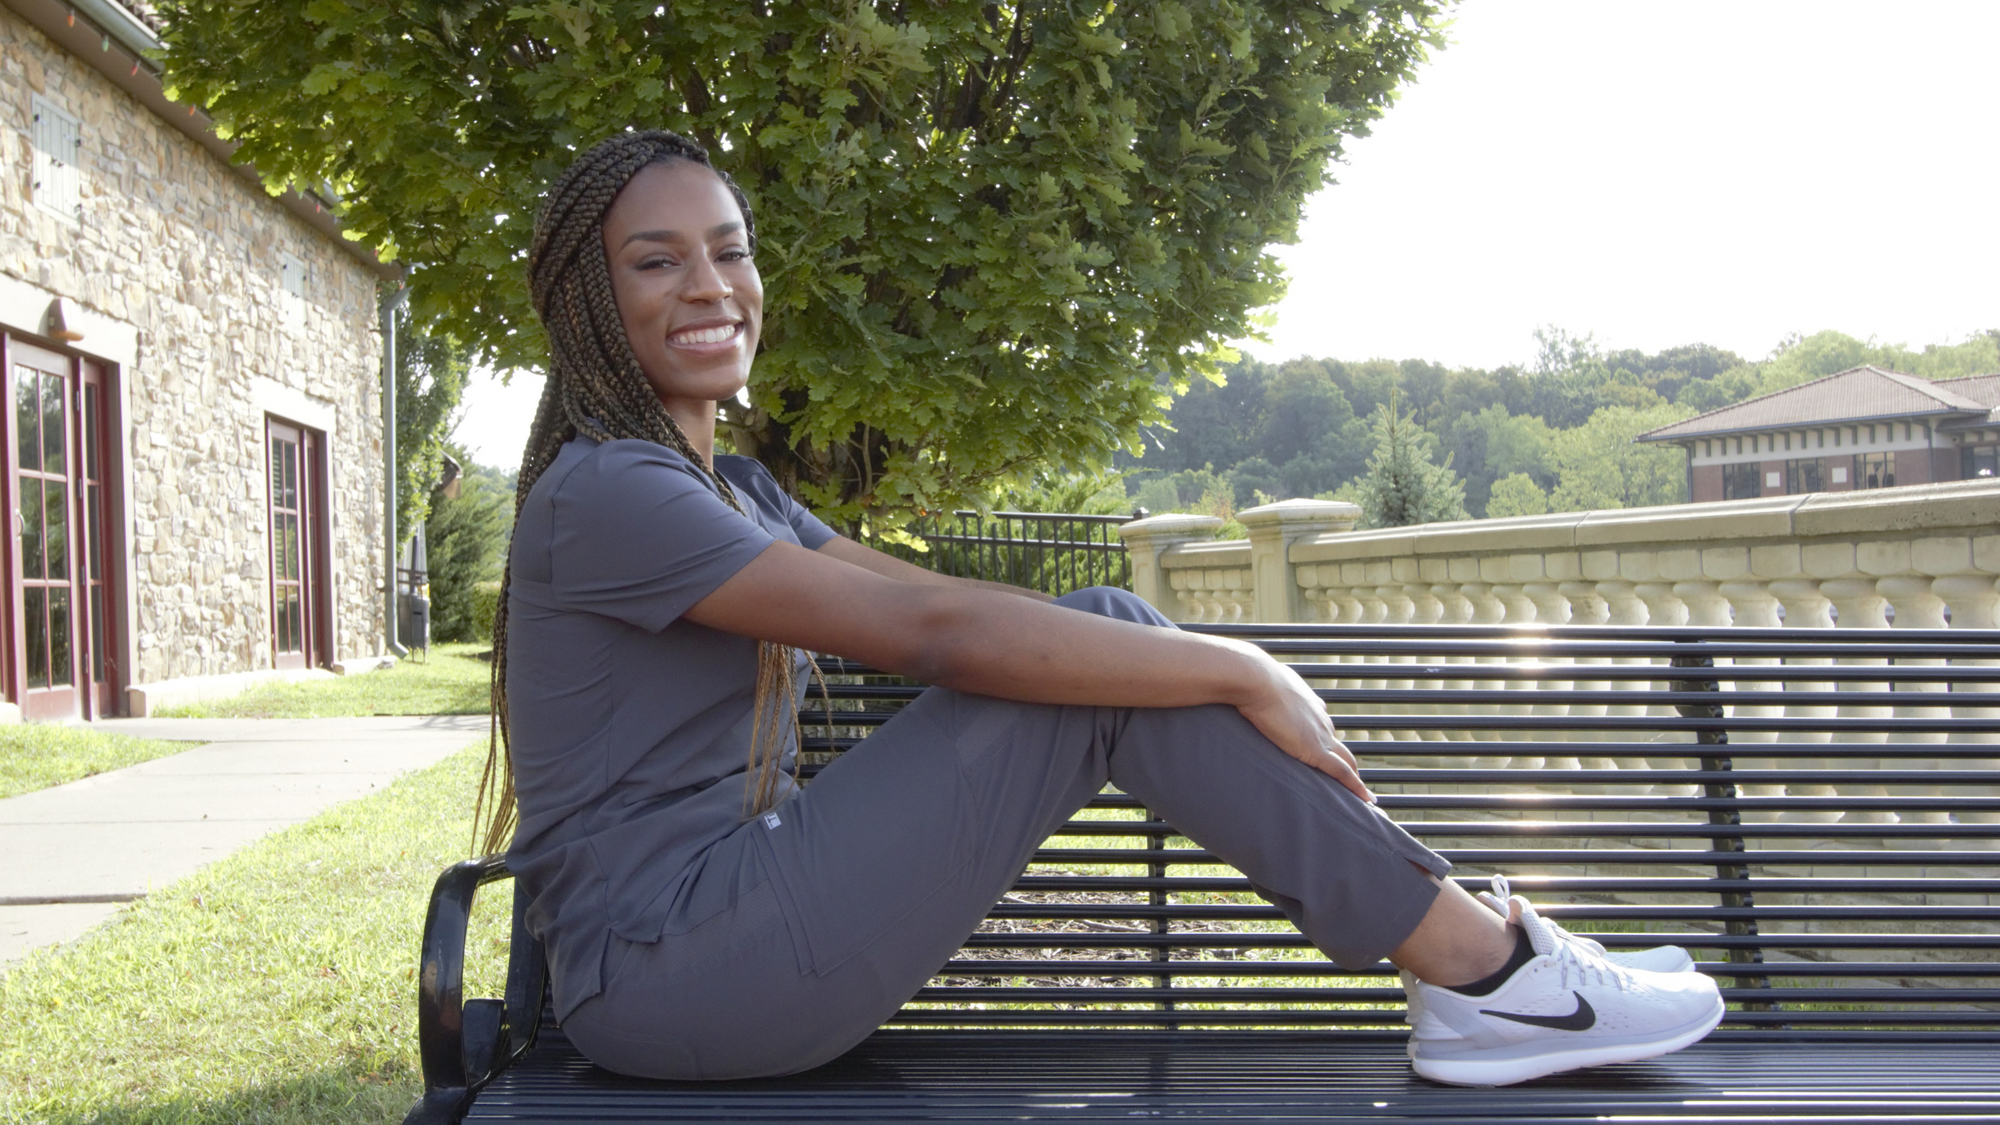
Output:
[1638, 366, 2000, 440]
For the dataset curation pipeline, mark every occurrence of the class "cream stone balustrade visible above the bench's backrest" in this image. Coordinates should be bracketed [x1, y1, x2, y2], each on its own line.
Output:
[1120, 478, 2000, 629]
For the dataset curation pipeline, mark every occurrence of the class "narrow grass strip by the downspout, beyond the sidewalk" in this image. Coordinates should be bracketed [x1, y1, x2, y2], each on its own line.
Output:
[160, 643, 492, 719]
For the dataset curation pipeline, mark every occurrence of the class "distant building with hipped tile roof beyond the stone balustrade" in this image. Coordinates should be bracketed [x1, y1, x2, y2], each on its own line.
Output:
[1638, 366, 2000, 502]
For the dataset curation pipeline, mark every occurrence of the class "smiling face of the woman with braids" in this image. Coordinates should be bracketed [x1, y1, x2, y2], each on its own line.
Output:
[604, 160, 764, 414]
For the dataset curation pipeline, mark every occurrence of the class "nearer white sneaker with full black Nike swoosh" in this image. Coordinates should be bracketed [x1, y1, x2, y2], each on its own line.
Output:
[1410, 897, 1722, 1085]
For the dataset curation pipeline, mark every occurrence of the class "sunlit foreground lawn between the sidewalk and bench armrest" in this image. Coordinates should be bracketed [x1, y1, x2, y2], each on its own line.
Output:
[0, 749, 508, 1125]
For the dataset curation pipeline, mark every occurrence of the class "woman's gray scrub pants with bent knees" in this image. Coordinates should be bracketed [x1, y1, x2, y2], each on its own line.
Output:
[564, 589, 1450, 1079]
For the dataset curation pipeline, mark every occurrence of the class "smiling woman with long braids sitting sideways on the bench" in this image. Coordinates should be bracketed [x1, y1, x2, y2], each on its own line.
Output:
[482, 132, 1722, 1083]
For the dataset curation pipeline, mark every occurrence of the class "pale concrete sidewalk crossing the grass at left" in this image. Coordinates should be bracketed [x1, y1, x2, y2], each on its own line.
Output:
[0, 715, 486, 963]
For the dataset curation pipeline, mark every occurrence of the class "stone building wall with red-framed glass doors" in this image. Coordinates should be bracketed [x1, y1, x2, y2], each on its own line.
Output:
[0, 0, 390, 719]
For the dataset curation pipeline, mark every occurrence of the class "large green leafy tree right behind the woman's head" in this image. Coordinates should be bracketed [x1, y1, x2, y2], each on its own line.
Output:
[160, 0, 1444, 524]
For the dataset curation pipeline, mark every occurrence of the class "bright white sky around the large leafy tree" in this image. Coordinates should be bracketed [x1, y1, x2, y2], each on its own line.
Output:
[456, 0, 2000, 468]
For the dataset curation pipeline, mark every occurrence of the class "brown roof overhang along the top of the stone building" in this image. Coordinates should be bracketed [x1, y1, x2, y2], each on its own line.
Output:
[0, 0, 402, 280]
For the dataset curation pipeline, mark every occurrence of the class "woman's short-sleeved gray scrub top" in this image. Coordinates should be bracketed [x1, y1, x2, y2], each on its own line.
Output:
[506, 436, 834, 1019]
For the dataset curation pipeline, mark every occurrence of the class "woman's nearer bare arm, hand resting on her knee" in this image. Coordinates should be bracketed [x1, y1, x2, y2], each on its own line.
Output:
[686, 542, 1372, 799]
